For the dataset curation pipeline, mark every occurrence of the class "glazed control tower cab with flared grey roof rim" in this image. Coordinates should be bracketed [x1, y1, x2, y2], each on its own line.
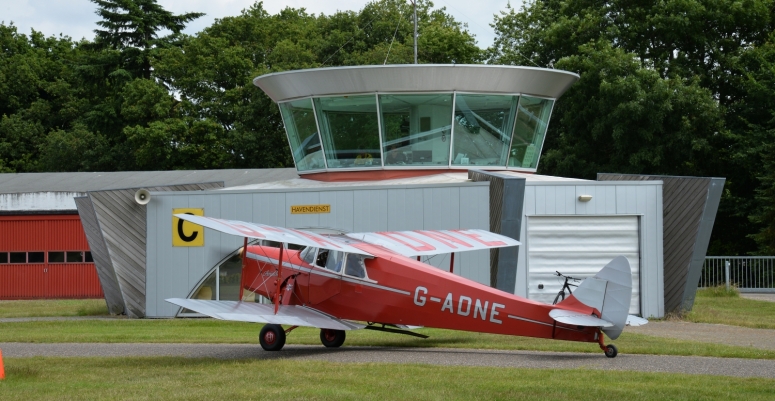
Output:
[253, 65, 579, 181]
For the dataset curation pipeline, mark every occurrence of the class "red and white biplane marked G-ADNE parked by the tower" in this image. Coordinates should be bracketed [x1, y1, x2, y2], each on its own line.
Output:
[167, 214, 647, 357]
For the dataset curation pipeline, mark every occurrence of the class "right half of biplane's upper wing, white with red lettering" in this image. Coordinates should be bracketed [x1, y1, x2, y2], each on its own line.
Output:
[346, 229, 520, 257]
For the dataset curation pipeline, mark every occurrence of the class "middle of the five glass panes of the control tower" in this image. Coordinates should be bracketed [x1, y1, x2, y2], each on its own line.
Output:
[379, 93, 452, 166]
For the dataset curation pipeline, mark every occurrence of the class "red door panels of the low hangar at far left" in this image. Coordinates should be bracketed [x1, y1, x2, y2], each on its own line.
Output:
[0, 215, 103, 299]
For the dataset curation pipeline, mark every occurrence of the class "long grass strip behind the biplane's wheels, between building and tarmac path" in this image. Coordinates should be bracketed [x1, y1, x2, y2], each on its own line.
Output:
[0, 319, 775, 359]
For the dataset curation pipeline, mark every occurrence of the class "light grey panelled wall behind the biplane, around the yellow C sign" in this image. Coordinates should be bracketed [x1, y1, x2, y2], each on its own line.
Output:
[146, 182, 490, 317]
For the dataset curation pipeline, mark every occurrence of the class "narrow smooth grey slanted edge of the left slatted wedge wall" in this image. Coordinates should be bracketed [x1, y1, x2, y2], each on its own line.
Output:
[75, 196, 124, 315]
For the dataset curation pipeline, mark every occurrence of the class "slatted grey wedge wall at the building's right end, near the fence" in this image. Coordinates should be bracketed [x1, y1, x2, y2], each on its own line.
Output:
[597, 173, 724, 313]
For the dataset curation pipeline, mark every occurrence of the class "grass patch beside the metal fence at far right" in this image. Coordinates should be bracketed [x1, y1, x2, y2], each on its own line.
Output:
[681, 287, 775, 329]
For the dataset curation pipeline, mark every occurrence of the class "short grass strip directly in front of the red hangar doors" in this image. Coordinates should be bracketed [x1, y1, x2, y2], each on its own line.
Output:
[0, 298, 108, 318]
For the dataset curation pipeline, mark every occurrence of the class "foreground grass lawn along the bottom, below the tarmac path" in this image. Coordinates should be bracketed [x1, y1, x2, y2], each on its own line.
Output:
[0, 357, 775, 401]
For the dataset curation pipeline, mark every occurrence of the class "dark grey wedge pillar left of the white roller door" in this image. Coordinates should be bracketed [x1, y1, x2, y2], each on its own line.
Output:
[468, 170, 526, 294]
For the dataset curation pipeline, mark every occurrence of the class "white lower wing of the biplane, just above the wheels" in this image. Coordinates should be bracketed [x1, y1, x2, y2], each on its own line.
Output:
[166, 298, 365, 330]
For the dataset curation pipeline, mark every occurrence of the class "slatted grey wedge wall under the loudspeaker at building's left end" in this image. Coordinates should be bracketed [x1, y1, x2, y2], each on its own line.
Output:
[89, 183, 223, 318]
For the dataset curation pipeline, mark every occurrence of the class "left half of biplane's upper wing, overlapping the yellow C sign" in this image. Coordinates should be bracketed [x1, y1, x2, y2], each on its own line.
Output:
[175, 214, 373, 256]
